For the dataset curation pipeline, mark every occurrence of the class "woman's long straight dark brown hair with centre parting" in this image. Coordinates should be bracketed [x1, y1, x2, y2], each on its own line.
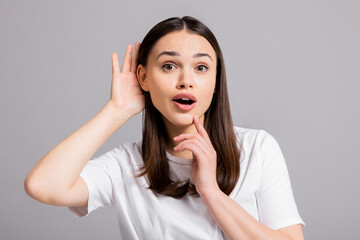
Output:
[137, 16, 240, 198]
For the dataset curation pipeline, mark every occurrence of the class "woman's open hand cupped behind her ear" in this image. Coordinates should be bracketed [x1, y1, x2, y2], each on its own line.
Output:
[109, 42, 145, 116]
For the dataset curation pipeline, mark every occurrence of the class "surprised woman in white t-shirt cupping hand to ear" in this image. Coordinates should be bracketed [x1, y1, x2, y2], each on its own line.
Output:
[25, 17, 305, 240]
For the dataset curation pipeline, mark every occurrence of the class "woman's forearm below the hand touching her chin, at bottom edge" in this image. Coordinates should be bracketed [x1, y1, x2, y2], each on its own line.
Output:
[202, 190, 289, 240]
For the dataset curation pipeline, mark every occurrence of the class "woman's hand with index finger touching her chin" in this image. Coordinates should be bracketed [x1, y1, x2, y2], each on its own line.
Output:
[174, 116, 220, 197]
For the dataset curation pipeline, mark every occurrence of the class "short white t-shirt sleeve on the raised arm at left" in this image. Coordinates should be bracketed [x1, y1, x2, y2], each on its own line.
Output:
[68, 148, 122, 218]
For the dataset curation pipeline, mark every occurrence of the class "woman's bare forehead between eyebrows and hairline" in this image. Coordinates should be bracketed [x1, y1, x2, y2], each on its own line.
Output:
[150, 30, 216, 59]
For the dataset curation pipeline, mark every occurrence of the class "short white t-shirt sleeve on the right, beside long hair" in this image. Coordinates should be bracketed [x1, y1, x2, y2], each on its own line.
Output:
[256, 130, 305, 230]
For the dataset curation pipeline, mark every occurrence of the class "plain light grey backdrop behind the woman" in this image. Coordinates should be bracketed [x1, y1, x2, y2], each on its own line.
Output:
[0, 0, 360, 239]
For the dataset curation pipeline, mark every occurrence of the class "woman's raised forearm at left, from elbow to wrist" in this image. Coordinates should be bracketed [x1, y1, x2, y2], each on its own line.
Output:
[25, 104, 130, 195]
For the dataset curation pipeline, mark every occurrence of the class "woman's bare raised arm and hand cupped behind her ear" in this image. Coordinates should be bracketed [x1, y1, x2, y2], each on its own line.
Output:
[24, 43, 144, 206]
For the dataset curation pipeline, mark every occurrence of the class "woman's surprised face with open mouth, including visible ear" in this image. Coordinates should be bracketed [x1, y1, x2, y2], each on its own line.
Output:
[138, 30, 217, 127]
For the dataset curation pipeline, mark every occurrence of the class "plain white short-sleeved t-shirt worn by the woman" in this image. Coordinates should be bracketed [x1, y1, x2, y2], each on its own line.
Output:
[69, 127, 305, 240]
